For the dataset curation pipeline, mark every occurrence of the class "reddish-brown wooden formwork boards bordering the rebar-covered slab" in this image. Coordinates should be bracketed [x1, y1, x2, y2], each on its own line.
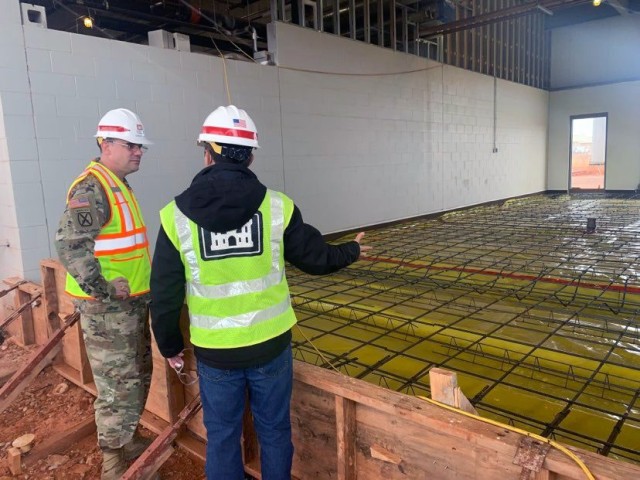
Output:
[5, 260, 640, 480]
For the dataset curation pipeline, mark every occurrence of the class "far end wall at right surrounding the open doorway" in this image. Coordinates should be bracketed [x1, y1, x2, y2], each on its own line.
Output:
[547, 15, 640, 190]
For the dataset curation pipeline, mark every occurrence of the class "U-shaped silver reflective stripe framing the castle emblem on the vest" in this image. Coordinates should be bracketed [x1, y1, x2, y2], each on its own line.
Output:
[174, 190, 284, 299]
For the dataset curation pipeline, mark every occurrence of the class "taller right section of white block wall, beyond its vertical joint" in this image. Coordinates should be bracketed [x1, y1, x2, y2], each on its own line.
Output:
[271, 23, 548, 232]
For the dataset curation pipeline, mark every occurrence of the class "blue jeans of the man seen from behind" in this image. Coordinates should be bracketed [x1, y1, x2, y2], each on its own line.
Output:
[198, 345, 293, 480]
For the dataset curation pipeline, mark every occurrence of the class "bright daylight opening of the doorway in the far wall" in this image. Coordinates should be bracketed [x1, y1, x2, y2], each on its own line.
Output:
[569, 114, 607, 190]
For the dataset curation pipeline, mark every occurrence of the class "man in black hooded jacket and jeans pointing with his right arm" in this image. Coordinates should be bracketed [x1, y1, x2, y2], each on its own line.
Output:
[151, 105, 370, 480]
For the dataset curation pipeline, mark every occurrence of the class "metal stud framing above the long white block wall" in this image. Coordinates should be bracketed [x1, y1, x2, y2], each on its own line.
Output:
[271, 0, 549, 88]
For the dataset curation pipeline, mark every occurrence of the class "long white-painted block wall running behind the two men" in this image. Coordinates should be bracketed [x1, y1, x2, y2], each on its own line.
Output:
[0, 0, 547, 280]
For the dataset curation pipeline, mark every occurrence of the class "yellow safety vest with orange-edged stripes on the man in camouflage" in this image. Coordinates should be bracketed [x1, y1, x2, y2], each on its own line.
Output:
[65, 162, 151, 299]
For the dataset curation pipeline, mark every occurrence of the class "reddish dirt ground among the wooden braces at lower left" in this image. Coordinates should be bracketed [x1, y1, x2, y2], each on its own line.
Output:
[0, 339, 205, 480]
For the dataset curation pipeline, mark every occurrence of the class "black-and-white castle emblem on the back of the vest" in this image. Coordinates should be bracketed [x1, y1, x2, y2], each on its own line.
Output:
[198, 211, 263, 260]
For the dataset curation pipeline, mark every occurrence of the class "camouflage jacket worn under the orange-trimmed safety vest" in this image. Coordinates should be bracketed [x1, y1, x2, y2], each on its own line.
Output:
[55, 159, 149, 313]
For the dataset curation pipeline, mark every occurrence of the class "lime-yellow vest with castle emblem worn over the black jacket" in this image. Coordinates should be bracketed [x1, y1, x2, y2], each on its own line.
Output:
[160, 190, 296, 348]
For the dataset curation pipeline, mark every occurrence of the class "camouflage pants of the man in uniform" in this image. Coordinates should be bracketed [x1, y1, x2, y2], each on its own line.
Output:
[81, 305, 152, 448]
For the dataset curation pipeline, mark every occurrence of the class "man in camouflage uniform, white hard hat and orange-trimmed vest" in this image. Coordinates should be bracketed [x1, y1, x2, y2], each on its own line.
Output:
[55, 109, 152, 480]
